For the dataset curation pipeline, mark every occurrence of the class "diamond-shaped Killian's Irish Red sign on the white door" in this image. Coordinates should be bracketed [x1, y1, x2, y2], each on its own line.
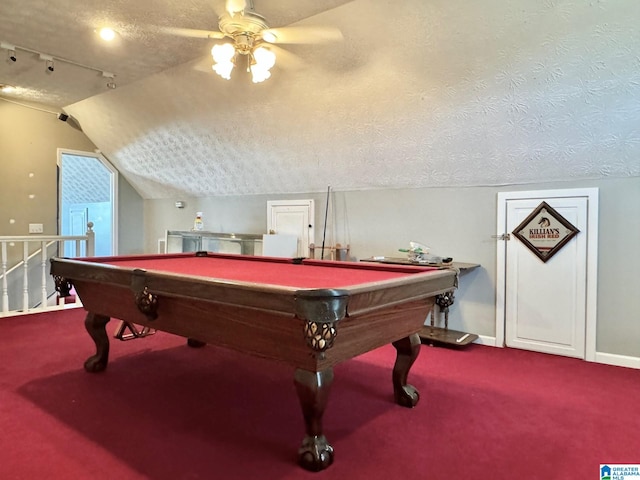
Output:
[513, 202, 580, 262]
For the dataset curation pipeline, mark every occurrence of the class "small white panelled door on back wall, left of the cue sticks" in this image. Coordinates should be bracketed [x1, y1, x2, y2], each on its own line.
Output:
[267, 200, 315, 257]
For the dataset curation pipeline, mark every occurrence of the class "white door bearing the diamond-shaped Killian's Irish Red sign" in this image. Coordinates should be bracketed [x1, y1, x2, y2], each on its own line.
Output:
[496, 189, 597, 359]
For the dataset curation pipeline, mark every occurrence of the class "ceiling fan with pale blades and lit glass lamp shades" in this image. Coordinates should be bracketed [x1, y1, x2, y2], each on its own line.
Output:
[164, 0, 343, 83]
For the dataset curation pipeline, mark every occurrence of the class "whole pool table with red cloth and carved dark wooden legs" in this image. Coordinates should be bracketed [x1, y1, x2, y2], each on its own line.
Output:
[51, 252, 457, 471]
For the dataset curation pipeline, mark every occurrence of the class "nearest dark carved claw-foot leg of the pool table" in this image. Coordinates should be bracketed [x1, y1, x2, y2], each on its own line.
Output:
[294, 368, 333, 472]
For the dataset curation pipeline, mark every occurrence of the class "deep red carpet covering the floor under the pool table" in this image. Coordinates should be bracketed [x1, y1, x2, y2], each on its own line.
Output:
[0, 310, 640, 480]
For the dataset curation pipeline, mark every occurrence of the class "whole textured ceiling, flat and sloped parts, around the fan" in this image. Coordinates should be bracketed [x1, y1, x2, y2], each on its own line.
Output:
[0, 0, 640, 198]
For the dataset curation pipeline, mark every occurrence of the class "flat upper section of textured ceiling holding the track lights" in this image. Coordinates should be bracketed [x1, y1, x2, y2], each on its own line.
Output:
[0, 0, 347, 107]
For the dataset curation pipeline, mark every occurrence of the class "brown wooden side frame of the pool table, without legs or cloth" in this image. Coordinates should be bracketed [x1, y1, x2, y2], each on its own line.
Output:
[51, 258, 454, 371]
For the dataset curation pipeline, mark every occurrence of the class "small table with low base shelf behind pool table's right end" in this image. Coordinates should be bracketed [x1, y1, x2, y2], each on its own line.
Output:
[362, 257, 480, 347]
